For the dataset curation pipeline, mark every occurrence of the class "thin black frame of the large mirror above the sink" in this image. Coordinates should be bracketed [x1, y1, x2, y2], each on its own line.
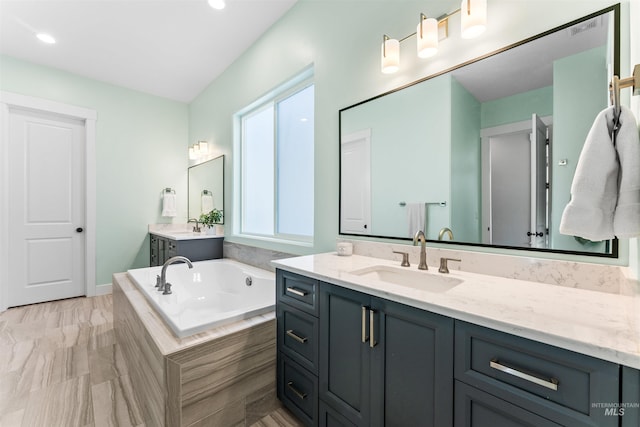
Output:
[338, 3, 620, 258]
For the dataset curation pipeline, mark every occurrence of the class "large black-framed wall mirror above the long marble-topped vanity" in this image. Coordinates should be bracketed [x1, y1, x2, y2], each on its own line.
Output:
[340, 6, 619, 257]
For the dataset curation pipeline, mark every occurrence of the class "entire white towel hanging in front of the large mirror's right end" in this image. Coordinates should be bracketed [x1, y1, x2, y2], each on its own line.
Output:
[560, 107, 640, 241]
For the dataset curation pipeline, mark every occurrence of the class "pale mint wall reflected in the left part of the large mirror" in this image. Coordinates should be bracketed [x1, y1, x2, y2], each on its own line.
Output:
[341, 76, 451, 239]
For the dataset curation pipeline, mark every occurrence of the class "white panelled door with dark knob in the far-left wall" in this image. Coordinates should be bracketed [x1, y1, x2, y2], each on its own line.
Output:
[7, 109, 86, 307]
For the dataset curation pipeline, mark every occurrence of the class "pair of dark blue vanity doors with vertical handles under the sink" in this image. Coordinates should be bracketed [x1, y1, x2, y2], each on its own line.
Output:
[319, 283, 453, 427]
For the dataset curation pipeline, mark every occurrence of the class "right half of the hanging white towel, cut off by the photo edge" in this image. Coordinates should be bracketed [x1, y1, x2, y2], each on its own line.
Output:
[613, 107, 640, 239]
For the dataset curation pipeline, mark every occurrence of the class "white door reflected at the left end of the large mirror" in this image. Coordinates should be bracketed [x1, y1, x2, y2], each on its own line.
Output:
[340, 130, 371, 234]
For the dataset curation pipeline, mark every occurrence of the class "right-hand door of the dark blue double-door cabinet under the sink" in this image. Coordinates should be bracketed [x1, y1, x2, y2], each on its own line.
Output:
[371, 298, 453, 427]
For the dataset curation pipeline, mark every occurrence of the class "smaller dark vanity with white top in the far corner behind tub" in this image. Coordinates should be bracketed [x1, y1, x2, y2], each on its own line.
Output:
[149, 231, 224, 267]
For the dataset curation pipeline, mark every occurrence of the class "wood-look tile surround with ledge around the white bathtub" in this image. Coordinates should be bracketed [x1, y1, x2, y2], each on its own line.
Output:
[113, 273, 296, 426]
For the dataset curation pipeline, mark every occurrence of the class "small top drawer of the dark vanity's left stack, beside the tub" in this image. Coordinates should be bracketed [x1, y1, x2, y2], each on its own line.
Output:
[276, 270, 318, 317]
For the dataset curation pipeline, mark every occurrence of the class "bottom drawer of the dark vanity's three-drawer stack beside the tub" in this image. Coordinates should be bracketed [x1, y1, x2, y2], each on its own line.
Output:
[278, 352, 318, 426]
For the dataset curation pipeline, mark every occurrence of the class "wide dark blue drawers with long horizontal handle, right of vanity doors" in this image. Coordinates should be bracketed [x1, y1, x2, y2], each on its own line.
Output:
[454, 320, 620, 427]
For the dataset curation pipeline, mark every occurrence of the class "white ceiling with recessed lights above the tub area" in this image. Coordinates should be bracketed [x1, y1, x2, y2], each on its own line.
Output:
[0, 0, 296, 102]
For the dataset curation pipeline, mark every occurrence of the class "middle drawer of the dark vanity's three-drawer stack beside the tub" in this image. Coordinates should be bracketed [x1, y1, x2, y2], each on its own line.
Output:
[277, 304, 318, 375]
